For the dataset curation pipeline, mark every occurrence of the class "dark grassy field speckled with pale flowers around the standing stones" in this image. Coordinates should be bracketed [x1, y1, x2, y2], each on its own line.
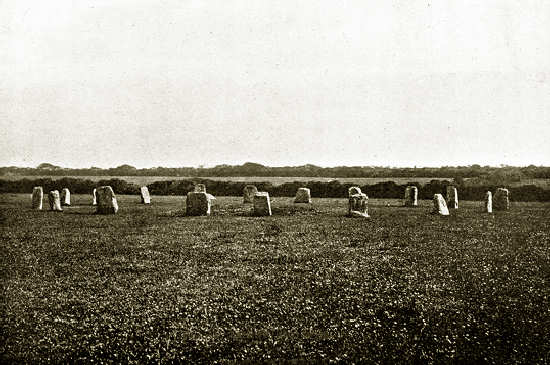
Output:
[0, 195, 550, 363]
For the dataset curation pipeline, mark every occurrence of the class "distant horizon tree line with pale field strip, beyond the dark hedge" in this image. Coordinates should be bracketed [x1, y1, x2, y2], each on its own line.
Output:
[0, 162, 550, 179]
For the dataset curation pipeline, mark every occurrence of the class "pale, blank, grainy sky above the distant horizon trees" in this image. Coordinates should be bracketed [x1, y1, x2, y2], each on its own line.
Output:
[0, 0, 550, 168]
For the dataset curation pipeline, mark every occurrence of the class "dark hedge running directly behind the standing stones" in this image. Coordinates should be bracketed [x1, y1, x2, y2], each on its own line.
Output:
[0, 178, 550, 202]
